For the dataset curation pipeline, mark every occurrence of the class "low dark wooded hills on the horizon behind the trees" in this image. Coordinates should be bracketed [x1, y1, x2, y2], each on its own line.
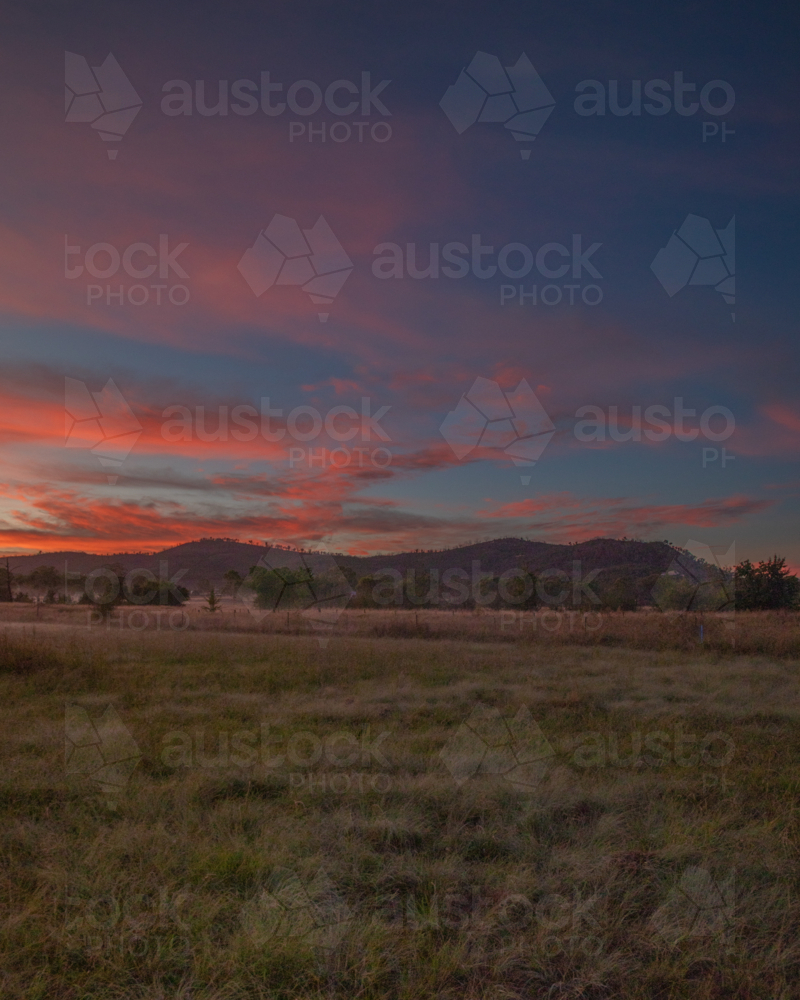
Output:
[3, 538, 675, 600]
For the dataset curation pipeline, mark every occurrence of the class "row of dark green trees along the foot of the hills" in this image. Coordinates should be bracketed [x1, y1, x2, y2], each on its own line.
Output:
[0, 555, 800, 611]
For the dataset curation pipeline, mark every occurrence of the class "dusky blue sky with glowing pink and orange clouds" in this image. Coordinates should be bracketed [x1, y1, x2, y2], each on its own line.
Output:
[0, 0, 800, 569]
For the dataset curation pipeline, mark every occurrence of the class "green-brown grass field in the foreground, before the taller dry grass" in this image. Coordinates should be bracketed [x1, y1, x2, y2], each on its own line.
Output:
[0, 626, 800, 1000]
